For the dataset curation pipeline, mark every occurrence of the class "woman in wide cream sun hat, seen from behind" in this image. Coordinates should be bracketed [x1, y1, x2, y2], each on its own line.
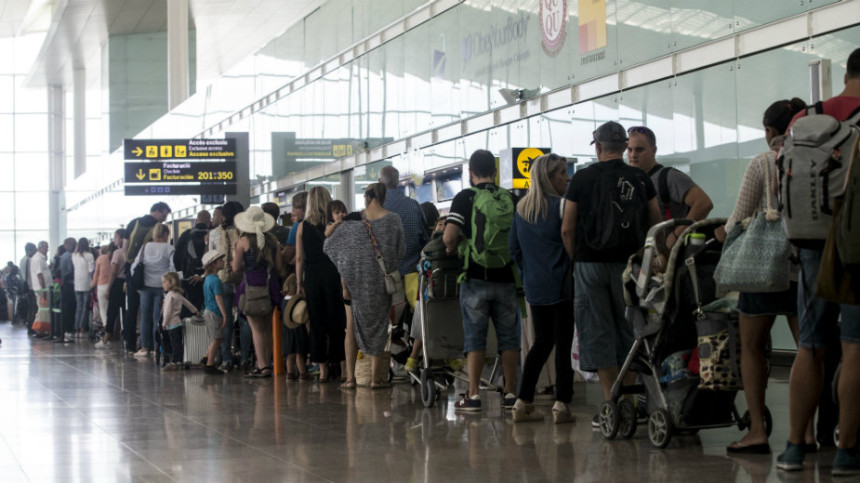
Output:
[232, 206, 284, 377]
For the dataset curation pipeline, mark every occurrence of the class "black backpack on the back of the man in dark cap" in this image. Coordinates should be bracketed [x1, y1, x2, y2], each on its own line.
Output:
[584, 166, 648, 253]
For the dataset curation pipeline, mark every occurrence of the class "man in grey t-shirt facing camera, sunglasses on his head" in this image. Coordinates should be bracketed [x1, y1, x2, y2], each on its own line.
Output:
[627, 126, 714, 246]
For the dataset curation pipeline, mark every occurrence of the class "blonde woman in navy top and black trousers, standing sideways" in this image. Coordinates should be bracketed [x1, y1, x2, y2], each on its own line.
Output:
[508, 154, 574, 423]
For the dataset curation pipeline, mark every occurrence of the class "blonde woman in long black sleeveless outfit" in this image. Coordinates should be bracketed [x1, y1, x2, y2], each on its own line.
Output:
[296, 186, 346, 382]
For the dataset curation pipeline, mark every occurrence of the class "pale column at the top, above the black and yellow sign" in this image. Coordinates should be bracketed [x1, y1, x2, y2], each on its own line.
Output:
[167, 0, 188, 110]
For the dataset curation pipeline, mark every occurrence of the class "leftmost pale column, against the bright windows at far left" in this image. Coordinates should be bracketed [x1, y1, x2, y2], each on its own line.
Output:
[48, 86, 66, 250]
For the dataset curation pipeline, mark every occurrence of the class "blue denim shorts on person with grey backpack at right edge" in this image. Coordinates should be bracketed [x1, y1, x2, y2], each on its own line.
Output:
[797, 248, 860, 349]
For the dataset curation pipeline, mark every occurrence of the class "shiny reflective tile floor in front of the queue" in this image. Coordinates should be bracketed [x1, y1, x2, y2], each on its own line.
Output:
[0, 322, 848, 483]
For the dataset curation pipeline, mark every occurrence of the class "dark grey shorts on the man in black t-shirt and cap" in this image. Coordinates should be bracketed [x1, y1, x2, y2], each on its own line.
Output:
[573, 262, 633, 371]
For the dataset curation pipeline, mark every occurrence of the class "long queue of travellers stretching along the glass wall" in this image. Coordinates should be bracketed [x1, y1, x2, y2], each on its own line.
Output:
[3, 45, 860, 476]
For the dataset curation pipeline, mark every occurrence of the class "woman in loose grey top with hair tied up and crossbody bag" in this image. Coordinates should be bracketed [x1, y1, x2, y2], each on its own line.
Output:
[324, 183, 406, 389]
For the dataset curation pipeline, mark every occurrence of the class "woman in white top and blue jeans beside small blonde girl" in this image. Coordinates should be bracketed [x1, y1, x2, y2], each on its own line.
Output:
[131, 223, 176, 357]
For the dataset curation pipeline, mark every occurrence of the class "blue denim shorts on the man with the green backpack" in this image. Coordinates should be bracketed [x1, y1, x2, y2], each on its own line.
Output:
[460, 279, 520, 353]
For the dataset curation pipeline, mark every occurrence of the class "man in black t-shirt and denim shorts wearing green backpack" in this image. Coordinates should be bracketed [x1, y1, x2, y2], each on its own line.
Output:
[442, 149, 520, 412]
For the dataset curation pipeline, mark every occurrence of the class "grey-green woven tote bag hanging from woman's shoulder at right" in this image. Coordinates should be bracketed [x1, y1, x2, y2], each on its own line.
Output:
[714, 153, 791, 293]
